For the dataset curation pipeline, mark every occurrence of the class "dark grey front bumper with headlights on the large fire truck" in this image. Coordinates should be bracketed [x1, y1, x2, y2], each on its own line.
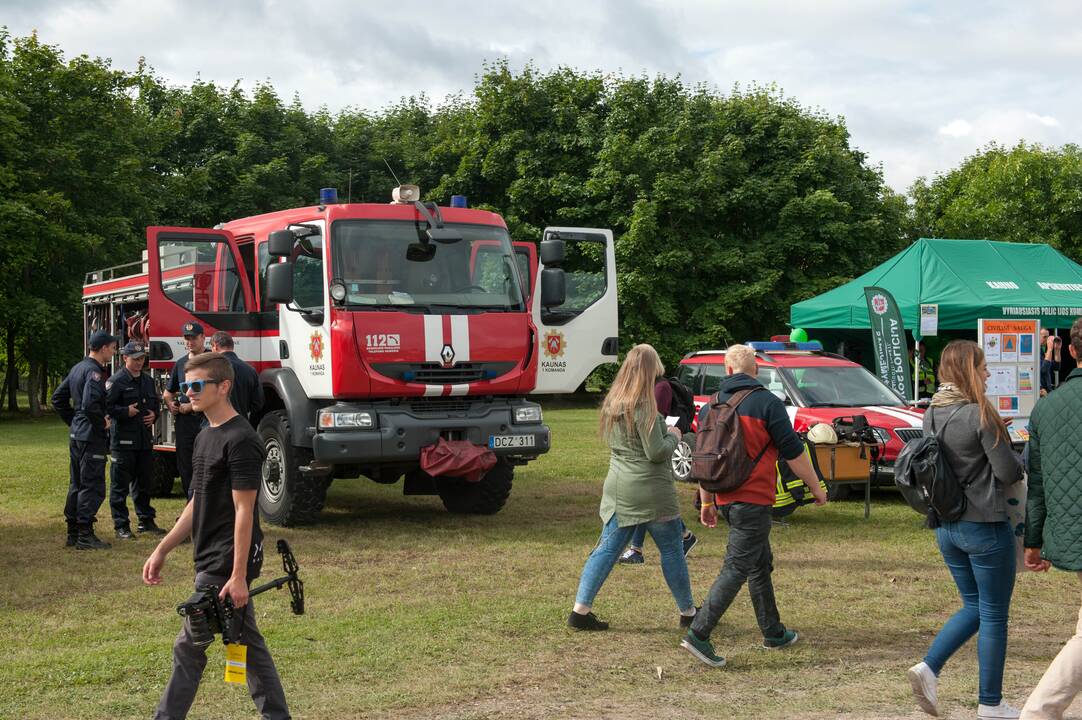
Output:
[312, 397, 551, 464]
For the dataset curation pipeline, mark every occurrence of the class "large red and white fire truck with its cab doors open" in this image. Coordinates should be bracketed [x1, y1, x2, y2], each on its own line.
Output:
[83, 185, 617, 524]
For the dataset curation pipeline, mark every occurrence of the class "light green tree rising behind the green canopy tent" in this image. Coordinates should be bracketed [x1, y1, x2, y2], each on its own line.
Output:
[910, 143, 1082, 260]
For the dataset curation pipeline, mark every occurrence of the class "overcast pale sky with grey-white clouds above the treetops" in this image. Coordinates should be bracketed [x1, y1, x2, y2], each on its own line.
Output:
[0, 0, 1082, 191]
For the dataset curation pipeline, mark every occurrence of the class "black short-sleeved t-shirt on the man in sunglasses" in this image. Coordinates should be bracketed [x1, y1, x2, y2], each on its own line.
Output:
[192, 415, 263, 580]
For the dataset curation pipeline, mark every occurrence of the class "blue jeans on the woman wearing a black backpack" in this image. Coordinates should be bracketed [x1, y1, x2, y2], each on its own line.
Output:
[924, 520, 1015, 705]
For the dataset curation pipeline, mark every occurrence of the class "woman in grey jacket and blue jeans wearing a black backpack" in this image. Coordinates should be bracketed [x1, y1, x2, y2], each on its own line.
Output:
[908, 340, 1022, 720]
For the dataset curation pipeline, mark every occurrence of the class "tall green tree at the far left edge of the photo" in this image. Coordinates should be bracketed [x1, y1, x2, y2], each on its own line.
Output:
[0, 32, 150, 413]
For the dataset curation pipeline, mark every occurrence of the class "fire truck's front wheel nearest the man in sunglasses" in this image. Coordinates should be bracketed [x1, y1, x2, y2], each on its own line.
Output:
[259, 410, 331, 526]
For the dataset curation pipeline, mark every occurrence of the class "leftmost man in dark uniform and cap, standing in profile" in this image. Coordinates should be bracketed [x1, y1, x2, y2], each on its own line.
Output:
[52, 330, 117, 550]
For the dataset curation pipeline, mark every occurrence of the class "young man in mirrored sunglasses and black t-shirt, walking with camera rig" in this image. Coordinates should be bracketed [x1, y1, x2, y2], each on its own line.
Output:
[143, 353, 290, 720]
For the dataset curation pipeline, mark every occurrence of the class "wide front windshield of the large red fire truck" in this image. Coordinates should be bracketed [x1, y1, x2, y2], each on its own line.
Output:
[331, 220, 526, 312]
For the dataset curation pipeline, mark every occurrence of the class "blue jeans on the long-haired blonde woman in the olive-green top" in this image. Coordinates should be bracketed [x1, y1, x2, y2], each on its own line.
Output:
[575, 515, 695, 612]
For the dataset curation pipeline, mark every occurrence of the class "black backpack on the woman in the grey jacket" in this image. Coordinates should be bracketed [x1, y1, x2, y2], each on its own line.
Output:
[894, 405, 966, 527]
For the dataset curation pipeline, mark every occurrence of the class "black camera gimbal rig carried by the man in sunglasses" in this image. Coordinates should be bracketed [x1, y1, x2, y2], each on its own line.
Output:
[176, 540, 304, 645]
